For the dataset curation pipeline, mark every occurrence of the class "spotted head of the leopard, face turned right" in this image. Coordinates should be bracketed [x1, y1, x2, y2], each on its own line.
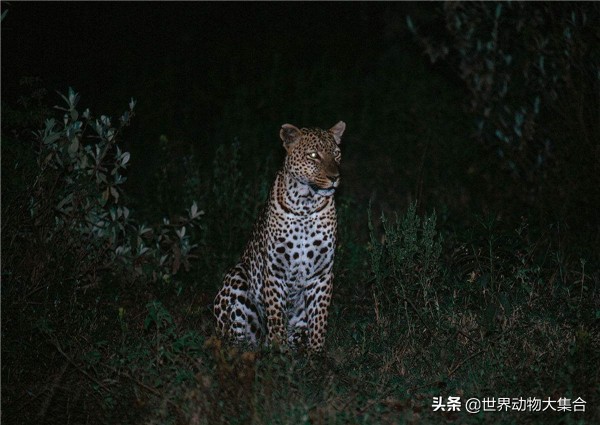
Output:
[279, 121, 346, 196]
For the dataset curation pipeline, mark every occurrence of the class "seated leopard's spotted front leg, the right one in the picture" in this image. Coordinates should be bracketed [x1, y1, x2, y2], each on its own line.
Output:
[306, 273, 333, 353]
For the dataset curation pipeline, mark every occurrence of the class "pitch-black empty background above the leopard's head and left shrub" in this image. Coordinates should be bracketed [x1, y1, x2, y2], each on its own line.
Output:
[2, 2, 468, 222]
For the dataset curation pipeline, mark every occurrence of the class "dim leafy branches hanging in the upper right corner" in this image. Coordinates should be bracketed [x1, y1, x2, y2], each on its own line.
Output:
[408, 2, 600, 181]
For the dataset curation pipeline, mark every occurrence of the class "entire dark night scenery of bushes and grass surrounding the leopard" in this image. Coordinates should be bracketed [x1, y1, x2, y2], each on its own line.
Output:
[1, 2, 600, 424]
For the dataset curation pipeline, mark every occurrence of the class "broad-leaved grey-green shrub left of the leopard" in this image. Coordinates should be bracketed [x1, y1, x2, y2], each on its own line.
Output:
[3, 89, 203, 294]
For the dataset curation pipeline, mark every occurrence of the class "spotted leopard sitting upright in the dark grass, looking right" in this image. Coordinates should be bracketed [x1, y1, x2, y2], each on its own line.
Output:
[213, 121, 346, 353]
